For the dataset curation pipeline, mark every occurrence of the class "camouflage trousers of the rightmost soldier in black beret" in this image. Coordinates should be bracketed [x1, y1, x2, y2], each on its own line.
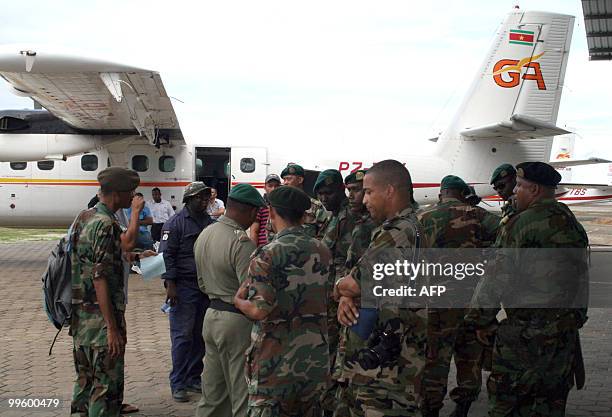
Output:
[487, 321, 577, 417]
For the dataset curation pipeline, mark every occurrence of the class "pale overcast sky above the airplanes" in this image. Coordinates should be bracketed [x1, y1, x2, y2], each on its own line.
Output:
[0, 0, 612, 174]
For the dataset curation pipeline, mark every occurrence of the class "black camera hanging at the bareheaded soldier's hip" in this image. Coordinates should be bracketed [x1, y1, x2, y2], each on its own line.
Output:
[357, 329, 402, 371]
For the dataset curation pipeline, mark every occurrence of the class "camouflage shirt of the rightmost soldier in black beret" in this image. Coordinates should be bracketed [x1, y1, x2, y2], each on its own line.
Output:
[466, 199, 588, 327]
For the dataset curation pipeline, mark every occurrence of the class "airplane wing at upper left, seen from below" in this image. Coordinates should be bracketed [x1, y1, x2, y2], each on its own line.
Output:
[0, 47, 182, 145]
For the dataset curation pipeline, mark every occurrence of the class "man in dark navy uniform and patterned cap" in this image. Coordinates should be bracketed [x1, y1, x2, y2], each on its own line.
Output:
[159, 181, 213, 402]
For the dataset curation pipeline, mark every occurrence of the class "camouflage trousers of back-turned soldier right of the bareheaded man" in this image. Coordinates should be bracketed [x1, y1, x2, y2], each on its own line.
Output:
[421, 308, 483, 410]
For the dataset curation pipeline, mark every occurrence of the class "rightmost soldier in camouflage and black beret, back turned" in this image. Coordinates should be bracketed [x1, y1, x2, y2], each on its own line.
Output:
[466, 162, 588, 417]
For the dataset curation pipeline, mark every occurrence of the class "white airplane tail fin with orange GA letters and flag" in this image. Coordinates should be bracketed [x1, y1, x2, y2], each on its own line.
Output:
[437, 10, 575, 181]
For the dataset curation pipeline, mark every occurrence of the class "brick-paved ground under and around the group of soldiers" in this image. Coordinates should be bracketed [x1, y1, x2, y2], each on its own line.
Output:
[0, 205, 612, 417]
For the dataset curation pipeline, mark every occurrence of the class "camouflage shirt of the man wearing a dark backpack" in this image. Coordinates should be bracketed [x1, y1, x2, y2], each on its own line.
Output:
[70, 203, 125, 346]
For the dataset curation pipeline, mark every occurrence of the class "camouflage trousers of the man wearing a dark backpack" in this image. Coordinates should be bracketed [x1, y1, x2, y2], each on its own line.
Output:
[70, 345, 124, 417]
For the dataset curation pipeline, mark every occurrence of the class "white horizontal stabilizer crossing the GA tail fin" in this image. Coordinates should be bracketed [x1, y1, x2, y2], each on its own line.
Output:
[461, 114, 570, 140]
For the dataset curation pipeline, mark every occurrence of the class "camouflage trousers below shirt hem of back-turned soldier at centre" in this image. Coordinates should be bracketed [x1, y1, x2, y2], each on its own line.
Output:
[247, 390, 323, 417]
